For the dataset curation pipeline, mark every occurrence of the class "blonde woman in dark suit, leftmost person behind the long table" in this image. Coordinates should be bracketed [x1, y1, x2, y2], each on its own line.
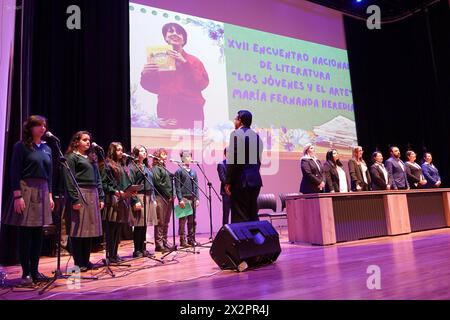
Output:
[300, 143, 325, 194]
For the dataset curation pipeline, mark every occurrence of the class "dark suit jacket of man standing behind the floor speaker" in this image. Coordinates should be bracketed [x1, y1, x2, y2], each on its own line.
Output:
[226, 127, 263, 189]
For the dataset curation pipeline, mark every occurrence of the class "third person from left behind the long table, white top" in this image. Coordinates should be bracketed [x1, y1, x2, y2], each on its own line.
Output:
[348, 146, 372, 191]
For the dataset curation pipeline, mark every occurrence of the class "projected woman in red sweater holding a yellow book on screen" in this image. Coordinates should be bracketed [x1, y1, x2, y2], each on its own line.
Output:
[141, 23, 209, 129]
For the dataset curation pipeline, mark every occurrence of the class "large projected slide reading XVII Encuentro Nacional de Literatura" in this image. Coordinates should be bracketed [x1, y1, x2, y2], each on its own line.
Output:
[130, 4, 357, 159]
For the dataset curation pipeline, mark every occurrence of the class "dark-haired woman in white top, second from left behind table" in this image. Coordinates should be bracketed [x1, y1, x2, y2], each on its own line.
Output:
[323, 149, 348, 192]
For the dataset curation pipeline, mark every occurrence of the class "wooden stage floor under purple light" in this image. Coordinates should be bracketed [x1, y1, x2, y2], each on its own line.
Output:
[0, 229, 450, 300]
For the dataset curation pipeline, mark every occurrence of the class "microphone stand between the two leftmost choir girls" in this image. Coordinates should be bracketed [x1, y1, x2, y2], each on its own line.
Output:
[39, 139, 98, 295]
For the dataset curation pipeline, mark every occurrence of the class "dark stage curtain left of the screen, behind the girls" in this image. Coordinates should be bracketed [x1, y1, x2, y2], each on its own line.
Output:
[0, 0, 130, 263]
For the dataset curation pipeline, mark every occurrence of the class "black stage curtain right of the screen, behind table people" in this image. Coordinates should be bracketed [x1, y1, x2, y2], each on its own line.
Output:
[344, 0, 450, 186]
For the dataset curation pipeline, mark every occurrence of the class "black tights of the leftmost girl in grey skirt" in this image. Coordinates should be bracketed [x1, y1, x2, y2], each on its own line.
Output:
[18, 227, 43, 277]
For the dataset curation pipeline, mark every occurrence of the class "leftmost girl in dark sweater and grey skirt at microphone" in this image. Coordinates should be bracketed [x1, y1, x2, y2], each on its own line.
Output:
[3, 115, 54, 286]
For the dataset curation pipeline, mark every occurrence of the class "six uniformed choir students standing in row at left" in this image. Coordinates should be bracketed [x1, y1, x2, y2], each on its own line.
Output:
[2, 115, 199, 286]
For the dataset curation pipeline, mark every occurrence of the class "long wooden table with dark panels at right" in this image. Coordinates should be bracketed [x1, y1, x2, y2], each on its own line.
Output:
[286, 188, 450, 245]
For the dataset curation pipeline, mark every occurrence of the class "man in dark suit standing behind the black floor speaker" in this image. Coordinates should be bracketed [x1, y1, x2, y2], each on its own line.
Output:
[225, 110, 263, 223]
